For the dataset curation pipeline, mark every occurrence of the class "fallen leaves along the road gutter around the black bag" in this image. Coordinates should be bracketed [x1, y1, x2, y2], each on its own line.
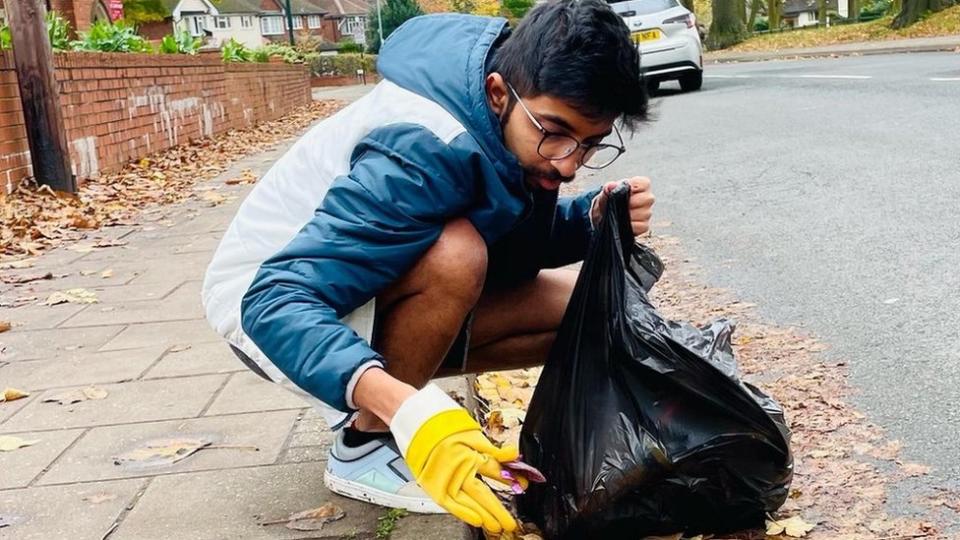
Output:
[477, 232, 948, 540]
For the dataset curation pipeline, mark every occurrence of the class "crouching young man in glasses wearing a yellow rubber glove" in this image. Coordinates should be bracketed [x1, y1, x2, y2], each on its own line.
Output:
[203, 0, 653, 532]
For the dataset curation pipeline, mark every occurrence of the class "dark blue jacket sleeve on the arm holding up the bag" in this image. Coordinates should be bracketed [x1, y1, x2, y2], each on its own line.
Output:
[543, 189, 600, 268]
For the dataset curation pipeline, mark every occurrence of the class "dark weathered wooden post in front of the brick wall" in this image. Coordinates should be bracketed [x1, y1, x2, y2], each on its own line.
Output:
[4, 0, 77, 193]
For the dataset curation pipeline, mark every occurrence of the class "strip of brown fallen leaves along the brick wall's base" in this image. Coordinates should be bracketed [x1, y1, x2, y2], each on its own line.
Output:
[0, 101, 344, 261]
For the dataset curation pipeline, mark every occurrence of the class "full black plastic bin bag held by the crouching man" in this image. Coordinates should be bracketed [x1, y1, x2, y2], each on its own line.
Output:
[519, 188, 793, 540]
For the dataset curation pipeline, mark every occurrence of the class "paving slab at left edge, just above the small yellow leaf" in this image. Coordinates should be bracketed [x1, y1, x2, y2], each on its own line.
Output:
[0, 347, 166, 392]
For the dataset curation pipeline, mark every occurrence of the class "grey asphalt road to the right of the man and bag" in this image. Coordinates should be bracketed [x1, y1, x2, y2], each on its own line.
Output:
[604, 53, 960, 516]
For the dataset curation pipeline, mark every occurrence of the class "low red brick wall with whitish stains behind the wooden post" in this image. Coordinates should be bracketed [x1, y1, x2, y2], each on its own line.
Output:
[0, 51, 310, 192]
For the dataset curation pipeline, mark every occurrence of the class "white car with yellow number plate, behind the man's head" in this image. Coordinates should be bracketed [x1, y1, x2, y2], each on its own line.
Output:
[608, 0, 703, 93]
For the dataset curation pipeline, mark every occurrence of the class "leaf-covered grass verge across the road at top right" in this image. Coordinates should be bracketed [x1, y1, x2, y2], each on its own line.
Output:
[727, 6, 960, 52]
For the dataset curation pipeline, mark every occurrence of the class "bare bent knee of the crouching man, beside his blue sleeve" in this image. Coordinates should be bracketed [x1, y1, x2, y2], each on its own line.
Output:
[424, 218, 487, 307]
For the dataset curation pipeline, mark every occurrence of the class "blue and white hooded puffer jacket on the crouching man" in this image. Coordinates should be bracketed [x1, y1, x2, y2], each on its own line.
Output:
[203, 15, 593, 427]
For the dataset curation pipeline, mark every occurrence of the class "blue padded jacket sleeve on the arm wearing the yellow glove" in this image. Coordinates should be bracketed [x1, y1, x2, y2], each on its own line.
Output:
[241, 125, 473, 412]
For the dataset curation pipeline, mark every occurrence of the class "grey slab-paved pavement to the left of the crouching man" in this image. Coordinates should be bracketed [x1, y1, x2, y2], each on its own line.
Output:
[0, 110, 470, 540]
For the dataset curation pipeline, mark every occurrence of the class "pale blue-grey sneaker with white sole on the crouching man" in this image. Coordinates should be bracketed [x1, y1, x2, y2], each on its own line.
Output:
[323, 430, 447, 514]
